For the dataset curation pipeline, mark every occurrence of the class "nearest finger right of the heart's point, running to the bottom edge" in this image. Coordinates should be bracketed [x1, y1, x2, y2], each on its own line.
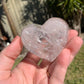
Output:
[49, 49, 70, 84]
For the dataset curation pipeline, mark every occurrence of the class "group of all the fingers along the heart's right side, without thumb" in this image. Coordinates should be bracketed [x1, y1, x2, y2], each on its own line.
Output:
[50, 30, 83, 84]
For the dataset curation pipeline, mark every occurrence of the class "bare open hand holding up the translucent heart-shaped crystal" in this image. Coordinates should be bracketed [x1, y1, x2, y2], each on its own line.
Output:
[0, 30, 83, 84]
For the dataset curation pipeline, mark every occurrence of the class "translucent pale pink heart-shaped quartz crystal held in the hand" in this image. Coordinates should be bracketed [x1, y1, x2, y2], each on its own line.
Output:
[21, 18, 69, 62]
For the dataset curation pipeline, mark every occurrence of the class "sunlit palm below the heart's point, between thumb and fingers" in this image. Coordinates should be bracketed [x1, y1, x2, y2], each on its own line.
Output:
[1, 52, 67, 84]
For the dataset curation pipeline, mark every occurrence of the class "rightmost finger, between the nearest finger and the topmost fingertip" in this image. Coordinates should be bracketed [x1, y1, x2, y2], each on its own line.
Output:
[66, 36, 83, 63]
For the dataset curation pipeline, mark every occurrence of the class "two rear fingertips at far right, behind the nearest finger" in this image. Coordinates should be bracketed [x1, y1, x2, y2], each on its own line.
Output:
[66, 30, 83, 63]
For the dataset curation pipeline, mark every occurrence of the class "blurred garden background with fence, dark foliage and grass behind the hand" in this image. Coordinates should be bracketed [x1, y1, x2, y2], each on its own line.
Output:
[0, 0, 84, 84]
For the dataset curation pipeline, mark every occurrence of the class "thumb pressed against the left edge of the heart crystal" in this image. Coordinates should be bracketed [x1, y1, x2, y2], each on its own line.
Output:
[0, 36, 22, 80]
